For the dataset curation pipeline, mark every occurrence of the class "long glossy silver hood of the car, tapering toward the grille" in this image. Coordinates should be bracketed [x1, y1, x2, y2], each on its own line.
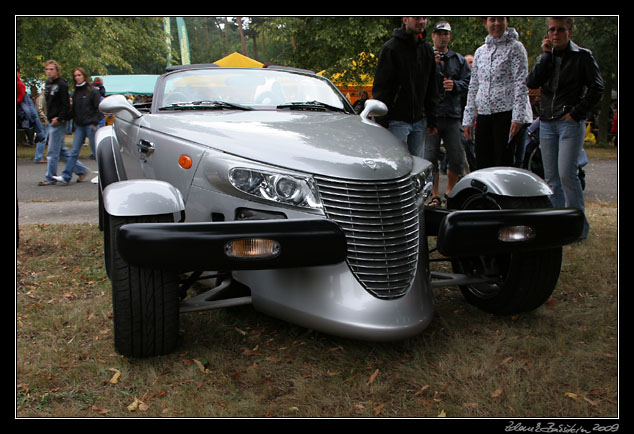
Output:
[145, 110, 413, 179]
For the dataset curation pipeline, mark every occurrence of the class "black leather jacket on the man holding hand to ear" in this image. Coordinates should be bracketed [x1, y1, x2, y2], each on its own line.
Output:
[526, 41, 603, 121]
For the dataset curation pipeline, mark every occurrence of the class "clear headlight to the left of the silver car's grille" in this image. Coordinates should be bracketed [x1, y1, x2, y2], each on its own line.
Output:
[229, 167, 321, 209]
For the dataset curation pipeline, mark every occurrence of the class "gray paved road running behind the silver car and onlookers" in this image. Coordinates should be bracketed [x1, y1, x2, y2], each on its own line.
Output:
[15, 155, 618, 224]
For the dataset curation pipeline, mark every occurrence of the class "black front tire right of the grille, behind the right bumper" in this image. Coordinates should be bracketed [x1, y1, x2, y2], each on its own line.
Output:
[452, 192, 562, 315]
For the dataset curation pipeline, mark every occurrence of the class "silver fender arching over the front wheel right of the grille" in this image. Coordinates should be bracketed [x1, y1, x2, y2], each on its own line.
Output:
[449, 167, 553, 200]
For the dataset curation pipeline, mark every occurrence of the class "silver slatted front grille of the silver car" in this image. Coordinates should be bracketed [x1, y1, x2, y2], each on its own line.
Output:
[315, 177, 419, 298]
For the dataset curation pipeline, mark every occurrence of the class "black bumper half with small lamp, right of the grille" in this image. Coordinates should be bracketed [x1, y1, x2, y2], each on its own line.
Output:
[425, 208, 584, 257]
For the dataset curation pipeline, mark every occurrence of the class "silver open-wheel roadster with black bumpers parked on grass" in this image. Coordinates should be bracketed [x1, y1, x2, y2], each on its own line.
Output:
[96, 65, 583, 357]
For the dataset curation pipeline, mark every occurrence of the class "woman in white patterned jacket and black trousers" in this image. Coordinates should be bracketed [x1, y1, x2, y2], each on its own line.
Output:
[462, 17, 532, 169]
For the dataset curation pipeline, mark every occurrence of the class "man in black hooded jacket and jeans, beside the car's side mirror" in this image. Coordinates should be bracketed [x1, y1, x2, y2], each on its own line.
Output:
[372, 17, 438, 157]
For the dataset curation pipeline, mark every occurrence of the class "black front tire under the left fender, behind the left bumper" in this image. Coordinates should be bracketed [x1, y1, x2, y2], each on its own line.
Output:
[104, 215, 180, 357]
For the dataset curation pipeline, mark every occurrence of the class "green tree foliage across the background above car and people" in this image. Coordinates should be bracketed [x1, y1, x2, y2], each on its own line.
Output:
[16, 16, 618, 111]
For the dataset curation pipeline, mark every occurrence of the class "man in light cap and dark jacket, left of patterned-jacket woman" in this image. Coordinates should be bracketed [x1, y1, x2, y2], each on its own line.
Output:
[424, 21, 471, 205]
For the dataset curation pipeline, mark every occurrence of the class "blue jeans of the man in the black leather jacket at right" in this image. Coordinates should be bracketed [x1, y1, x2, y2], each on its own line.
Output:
[539, 120, 590, 240]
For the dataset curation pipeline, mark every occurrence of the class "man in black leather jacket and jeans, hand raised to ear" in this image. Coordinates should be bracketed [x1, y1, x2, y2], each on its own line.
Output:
[526, 17, 603, 240]
